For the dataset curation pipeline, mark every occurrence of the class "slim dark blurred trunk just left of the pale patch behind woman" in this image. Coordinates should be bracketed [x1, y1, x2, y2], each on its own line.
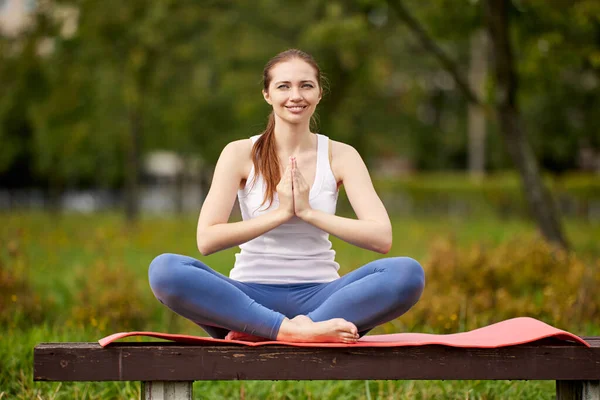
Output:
[125, 107, 142, 222]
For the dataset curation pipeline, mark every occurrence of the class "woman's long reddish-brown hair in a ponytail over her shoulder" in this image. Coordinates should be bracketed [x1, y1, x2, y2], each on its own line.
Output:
[252, 49, 323, 208]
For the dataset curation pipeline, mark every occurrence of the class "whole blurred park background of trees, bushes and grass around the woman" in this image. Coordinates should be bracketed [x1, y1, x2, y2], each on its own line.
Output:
[0, 0, 600, 399]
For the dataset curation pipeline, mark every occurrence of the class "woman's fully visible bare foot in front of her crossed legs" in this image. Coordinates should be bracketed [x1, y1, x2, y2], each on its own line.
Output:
[277, 315, 358, 343]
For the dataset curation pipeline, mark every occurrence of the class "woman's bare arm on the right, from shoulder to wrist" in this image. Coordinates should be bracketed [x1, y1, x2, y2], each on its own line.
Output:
[298, 142, 392, 254]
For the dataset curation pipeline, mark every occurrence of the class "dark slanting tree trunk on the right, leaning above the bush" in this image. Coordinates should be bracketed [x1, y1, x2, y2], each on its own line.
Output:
[485, 0, 568, 248]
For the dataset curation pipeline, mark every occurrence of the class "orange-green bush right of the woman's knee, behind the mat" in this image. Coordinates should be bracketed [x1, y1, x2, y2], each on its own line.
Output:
[401, 234, 600, 333]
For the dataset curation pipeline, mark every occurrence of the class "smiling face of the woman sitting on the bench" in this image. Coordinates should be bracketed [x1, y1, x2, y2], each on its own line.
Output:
[263, 58, 321, 124]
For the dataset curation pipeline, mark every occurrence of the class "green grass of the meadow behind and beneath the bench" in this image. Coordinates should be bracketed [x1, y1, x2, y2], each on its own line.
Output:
[0, 213, 600, 399]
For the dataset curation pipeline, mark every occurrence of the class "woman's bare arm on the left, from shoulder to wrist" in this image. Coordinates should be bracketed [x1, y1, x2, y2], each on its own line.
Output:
[196, 140, 293, 256]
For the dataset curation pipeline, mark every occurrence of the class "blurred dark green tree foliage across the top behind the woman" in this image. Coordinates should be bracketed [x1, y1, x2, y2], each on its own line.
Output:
[0, 0, 600, 191]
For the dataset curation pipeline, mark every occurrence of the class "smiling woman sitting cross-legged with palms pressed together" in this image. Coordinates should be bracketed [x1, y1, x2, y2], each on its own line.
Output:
[149, 50, 424, 343]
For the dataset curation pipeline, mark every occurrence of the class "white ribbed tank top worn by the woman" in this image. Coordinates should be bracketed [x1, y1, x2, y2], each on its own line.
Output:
[229, 134, 340, 284]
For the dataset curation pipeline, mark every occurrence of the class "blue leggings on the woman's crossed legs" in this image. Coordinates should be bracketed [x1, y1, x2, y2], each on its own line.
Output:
[148, 254, 425, 340]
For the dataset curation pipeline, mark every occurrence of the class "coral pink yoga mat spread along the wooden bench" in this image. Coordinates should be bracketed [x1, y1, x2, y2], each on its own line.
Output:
[98, 317, 590, 348]
